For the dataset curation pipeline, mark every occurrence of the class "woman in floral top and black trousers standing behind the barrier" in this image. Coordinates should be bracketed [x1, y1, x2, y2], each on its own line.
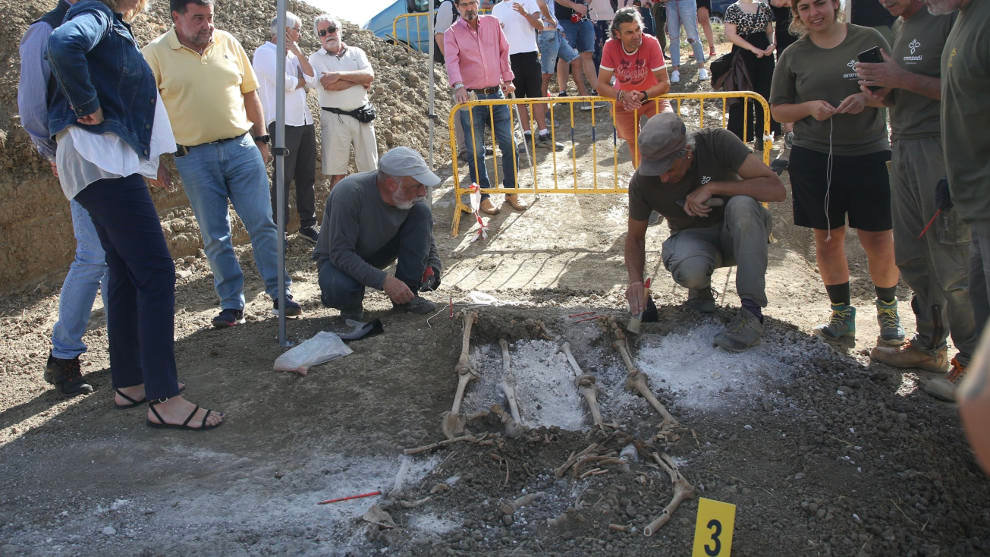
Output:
[725, 0, 780, 150]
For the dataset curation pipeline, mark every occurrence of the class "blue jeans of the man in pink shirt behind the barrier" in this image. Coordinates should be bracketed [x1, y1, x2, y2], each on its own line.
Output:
[460, 90, 516, 199]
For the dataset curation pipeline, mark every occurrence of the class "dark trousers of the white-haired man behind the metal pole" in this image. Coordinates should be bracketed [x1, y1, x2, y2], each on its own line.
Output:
[268, 122, 316, 228]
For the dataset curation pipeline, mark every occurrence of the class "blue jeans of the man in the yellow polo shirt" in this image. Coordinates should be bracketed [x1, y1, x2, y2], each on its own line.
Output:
[175, 134, 290, 309]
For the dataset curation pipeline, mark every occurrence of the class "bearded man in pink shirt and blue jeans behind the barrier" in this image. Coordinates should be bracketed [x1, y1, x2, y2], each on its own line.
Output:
[443, 0, 526, 215]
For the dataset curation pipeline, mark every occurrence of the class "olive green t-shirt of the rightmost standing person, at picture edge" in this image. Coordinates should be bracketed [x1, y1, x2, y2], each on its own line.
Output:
[942, 0, 990, 222]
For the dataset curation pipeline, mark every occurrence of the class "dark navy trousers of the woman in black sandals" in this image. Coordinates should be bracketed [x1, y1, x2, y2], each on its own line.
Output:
[76, 174, 179, 400]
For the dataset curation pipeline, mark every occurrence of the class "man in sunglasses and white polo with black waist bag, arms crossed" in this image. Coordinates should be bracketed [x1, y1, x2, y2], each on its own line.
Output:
[309, 14, 378, 188]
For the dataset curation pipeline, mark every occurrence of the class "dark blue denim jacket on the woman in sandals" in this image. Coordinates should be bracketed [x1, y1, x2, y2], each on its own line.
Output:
[47, 0, 157, 159]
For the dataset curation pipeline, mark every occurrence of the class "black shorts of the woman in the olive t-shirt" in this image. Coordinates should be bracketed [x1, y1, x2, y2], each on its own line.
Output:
[787, 146, 892, 231]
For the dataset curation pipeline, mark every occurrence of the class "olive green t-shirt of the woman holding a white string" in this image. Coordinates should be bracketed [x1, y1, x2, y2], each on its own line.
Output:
[770, 24, 890, 156]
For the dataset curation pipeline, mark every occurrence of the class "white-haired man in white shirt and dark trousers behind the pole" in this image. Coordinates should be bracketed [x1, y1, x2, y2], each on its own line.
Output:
[251, 12, 319, 243]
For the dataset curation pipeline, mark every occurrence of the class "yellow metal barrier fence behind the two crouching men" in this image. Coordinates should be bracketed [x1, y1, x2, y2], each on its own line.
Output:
[448, 91, 771, 236]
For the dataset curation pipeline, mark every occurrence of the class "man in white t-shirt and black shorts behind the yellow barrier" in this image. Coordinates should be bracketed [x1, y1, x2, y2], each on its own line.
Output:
[492, 0, 564, 149]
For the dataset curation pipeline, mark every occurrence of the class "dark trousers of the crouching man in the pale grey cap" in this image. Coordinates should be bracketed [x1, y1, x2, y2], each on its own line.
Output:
[317, 203, 433, 309]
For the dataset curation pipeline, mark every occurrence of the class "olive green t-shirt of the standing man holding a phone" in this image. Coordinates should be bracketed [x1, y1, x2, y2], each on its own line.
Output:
[890, 6, 956, 141]
